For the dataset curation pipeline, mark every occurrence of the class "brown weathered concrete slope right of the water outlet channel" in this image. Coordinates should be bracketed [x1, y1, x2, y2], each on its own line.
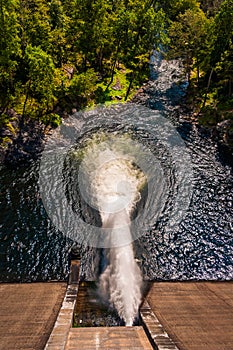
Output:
[146, 282, 233, 350]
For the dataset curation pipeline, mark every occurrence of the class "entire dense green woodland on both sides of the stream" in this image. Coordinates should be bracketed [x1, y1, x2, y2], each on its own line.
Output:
[0, 0, 233, 152]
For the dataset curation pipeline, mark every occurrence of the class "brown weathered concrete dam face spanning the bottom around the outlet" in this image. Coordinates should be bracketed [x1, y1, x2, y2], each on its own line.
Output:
[0, 280, 233, 350]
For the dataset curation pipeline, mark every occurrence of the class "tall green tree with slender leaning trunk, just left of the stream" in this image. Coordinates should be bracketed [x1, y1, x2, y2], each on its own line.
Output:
[117, 0, 167, 99]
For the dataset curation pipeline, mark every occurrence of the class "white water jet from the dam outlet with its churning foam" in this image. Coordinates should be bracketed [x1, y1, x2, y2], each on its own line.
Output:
[78, 136, 146, 326]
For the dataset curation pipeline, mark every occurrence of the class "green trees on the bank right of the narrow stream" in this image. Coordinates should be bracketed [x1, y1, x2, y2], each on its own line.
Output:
[165, 0, 233, 134]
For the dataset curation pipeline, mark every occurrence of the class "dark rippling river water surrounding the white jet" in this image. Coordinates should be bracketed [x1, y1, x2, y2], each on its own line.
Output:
[0, 53, 233, 282]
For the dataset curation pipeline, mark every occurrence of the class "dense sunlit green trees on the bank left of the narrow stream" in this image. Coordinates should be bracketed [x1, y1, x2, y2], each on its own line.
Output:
[0, 0, 171, 131]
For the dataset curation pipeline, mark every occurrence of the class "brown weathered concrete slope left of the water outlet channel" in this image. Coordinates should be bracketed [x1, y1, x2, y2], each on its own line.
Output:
[0, 282, 67, 350]
